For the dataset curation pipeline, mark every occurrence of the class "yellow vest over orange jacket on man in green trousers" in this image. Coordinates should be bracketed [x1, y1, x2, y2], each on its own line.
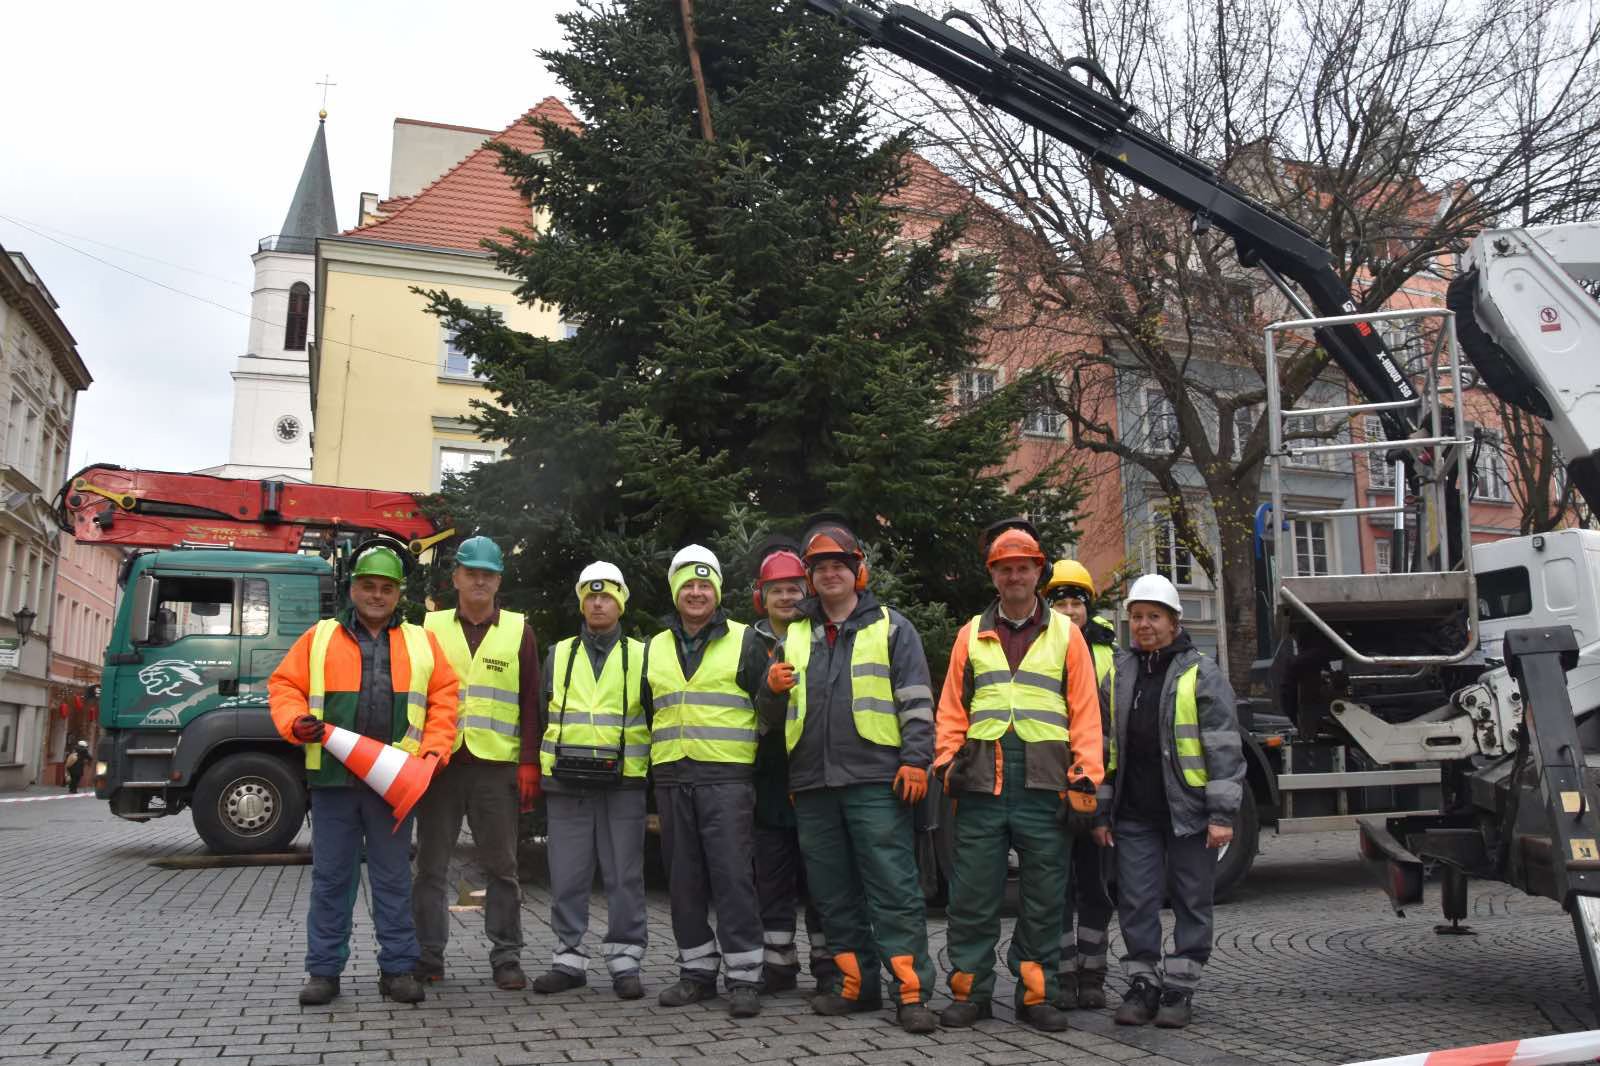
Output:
[966, 611, 1074, 744]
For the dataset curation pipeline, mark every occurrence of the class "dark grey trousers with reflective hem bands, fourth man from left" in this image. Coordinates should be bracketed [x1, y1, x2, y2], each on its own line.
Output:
[656, 781, 762, 988]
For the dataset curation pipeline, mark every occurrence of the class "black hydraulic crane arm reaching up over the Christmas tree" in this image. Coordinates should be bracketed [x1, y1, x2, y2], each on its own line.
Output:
[806, 0, 1418, 440]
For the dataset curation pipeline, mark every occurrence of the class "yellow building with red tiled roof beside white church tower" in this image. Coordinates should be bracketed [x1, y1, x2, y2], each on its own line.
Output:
[309, 98, 576, 491]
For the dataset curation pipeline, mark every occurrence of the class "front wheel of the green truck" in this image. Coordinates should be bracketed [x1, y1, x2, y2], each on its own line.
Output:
[190, 751, 306, 855]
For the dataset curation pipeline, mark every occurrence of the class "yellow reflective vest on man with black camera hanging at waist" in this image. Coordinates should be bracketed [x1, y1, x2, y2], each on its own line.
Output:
[539, 637, 650, 778]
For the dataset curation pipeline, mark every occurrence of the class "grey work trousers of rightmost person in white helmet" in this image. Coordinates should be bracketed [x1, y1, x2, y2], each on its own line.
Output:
[1112, 818, 1216, 989]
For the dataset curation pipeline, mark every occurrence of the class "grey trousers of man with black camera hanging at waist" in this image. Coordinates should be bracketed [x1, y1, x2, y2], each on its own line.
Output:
[544, 789, 646, 981]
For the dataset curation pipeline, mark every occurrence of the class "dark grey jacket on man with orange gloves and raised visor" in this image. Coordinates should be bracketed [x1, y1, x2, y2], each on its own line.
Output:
[755, 591, 933, 792]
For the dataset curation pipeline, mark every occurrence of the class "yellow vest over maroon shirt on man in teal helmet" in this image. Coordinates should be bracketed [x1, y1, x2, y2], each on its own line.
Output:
[422, 610, 526, 762]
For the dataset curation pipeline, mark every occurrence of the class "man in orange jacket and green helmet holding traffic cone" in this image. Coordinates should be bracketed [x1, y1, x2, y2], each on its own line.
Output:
[267, 547, 456, 1007]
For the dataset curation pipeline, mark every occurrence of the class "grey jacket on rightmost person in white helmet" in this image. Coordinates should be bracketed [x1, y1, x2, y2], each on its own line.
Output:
[1098, 633, 1245, 837]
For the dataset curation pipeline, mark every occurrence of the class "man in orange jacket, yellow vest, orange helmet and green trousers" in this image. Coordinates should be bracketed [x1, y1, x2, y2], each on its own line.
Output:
[933, 528, 1104, 1031]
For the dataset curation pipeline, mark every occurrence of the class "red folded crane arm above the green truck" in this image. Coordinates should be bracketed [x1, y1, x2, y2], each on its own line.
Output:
[56, 464, 454, 554]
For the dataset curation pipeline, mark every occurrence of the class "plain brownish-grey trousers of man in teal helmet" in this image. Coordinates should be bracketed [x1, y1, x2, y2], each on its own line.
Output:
[411, 749, 522, 972]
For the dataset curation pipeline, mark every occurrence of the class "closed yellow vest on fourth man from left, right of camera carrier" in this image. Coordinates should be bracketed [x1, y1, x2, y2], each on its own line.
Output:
[648, 621, 757, 763]
